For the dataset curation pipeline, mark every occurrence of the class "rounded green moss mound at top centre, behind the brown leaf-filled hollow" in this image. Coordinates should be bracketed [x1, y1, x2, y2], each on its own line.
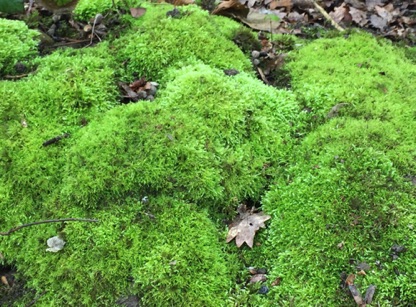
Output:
[113, 5, 251, 81]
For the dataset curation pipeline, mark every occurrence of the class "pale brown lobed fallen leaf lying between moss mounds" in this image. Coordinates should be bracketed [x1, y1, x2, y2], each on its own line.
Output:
[227, 204, 270, 248]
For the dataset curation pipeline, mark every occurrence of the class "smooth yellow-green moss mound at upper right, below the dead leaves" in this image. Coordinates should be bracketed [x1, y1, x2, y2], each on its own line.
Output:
[289, 33, 416, 174]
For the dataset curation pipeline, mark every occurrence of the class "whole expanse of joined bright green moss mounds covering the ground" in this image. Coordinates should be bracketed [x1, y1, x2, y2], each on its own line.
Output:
[0, 1, 416, 306]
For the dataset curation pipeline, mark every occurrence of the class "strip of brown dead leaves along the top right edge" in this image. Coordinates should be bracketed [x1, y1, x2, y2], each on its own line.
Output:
[213, 0, 416, 38]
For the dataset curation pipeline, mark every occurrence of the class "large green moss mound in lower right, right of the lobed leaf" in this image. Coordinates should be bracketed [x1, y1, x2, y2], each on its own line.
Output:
[263, 144, 416, 306]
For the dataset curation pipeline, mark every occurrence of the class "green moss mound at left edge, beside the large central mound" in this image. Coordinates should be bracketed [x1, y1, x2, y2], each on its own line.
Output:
[0, 45, 117, 229]
